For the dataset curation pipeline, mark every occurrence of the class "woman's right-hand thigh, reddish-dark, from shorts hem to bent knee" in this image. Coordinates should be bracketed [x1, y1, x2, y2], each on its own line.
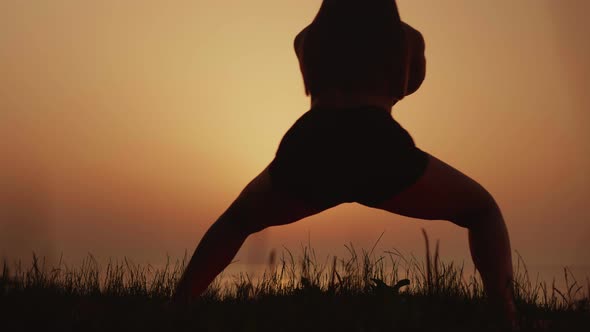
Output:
[371, 154, 497, 227]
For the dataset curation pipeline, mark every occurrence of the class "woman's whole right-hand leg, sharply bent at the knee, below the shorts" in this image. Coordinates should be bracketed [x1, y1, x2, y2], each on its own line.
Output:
[372, 155, 515, 323]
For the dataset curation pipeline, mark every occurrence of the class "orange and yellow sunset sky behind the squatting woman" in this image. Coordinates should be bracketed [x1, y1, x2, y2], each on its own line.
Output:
[0, 0, 590, 272]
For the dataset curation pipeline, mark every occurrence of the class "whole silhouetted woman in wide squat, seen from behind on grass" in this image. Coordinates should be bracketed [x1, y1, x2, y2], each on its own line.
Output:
[175, 0, 515, 322]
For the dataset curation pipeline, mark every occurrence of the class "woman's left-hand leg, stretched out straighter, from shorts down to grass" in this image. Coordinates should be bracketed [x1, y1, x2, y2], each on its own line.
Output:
[174, 163, 336, 302]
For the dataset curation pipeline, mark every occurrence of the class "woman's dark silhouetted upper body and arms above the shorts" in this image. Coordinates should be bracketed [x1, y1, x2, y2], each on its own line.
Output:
[294, 0, 425, 110]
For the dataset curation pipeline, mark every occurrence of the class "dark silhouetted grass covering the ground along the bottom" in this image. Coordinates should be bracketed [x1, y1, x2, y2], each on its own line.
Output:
[0, 233, 590, 331]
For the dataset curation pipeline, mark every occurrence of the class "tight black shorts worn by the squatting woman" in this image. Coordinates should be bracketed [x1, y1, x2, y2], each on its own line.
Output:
[269, 106, 428, 209]
